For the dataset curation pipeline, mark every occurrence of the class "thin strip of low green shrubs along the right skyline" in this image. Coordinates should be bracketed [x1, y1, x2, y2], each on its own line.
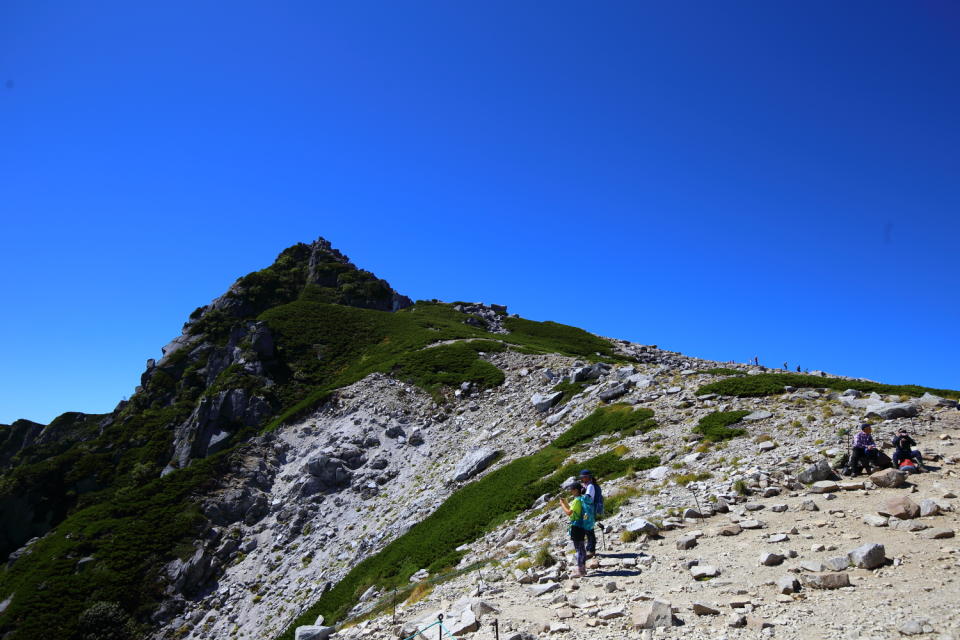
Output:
[697, 373, 960, 400]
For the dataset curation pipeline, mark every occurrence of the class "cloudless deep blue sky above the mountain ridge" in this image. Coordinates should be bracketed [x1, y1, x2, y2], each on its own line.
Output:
[0, 0, 960, 422]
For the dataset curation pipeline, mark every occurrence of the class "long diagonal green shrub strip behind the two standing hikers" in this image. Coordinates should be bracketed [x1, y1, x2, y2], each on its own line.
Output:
[279, 405, 659, 640]
